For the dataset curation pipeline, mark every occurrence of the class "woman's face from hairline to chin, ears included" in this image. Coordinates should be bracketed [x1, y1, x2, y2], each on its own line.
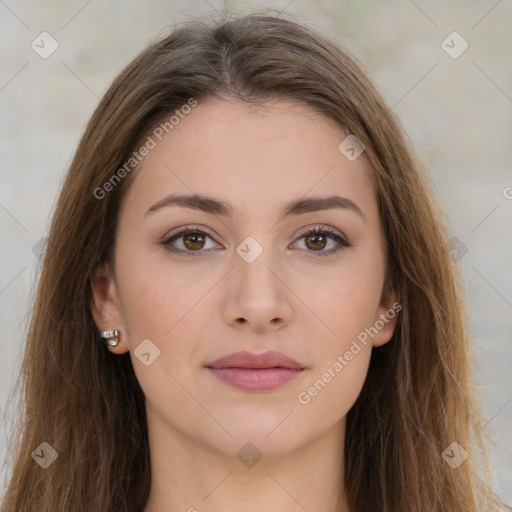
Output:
[92, 96, 397, 457]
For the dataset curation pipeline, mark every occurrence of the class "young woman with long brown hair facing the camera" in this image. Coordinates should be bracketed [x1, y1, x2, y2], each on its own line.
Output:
[1, 8, 506, 512]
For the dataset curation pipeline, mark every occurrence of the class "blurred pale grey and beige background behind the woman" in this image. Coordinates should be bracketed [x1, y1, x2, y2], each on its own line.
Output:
[0, 0, 512, 501]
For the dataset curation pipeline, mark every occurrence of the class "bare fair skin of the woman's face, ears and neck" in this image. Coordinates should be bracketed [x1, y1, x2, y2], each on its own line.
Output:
[92, 100, 397, 512]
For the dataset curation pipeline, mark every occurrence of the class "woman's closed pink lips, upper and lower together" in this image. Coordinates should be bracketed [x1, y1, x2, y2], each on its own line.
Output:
[206, 351, 305, 392]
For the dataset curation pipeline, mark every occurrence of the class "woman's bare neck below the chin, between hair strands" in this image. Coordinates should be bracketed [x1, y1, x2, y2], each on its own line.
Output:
[144, 412, 350, 512]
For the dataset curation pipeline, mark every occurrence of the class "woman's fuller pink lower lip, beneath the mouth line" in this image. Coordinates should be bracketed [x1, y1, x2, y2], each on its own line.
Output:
[208, 368, 303, 391]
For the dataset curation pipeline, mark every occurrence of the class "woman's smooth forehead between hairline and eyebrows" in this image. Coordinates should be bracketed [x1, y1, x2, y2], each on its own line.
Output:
[120, 99, 375, 222]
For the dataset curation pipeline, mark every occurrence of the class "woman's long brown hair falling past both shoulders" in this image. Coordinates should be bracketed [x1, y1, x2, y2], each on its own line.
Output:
[1, 9, 506, 512]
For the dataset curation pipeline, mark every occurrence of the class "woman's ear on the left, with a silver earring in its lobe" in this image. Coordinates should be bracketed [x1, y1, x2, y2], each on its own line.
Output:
[90, 263, 128, 354]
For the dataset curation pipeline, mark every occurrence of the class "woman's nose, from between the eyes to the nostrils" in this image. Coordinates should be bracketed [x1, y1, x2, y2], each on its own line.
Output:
[223, 242, 293, 332]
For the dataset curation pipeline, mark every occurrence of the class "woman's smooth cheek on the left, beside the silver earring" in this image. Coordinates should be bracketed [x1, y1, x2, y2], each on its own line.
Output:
[119, 252, 218, 394]
